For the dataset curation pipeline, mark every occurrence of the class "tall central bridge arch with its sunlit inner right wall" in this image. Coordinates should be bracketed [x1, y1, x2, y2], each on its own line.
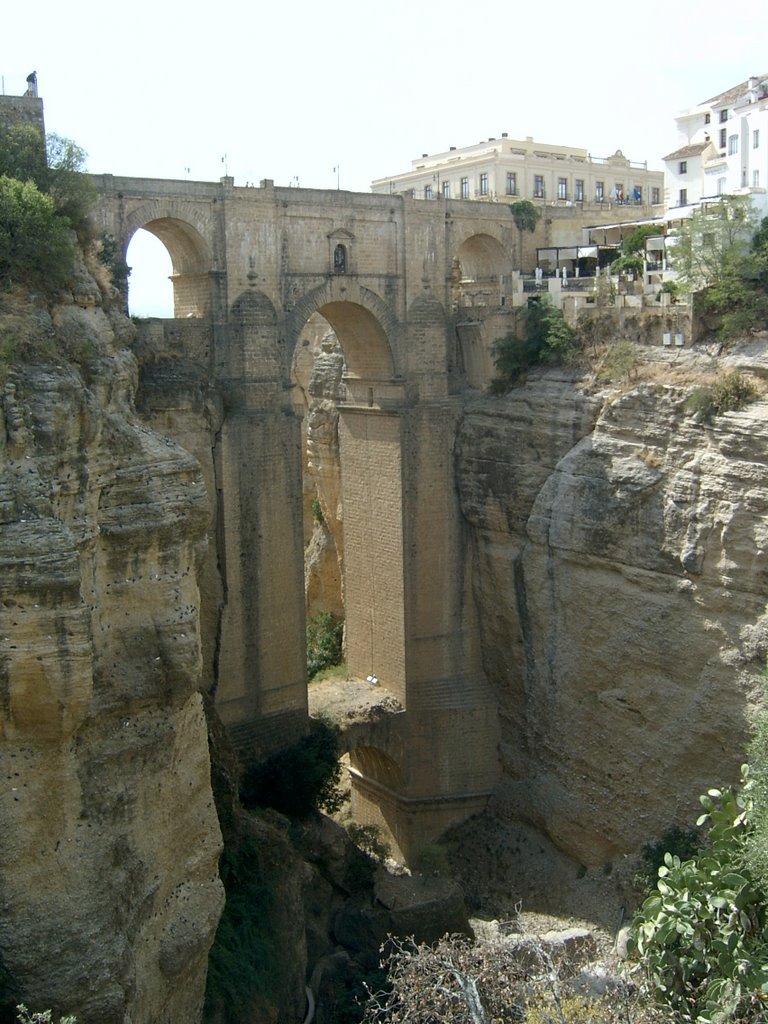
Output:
[287, 274, 406, 705]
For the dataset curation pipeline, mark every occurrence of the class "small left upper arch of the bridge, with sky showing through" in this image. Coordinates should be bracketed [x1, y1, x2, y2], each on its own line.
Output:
[121, 201, 213, 318]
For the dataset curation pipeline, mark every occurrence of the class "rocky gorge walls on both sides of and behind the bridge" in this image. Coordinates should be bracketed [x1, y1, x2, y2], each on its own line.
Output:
[0, 235, 768, 1024]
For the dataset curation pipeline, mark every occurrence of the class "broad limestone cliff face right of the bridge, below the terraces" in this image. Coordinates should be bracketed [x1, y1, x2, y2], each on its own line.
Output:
[457, 364, 768, 866]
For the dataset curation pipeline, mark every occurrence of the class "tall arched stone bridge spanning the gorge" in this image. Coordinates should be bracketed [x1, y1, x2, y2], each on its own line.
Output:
[88, 175, 524, 853]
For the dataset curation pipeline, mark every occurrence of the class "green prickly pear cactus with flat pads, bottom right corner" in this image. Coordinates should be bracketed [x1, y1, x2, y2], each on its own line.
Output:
[634, 766, 768, 1024]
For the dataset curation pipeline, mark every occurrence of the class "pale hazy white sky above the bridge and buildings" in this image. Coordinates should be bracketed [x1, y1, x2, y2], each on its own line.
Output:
[6, 0, 768, 309]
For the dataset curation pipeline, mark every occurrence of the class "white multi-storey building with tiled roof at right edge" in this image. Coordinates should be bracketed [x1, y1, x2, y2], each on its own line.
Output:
[665, 74, 768, 215]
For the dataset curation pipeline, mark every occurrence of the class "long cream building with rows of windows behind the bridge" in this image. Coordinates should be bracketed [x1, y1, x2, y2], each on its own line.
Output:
[371, 133, 664, 207]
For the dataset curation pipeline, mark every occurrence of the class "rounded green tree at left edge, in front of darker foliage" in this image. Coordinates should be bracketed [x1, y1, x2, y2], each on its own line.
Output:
[0, 177, 74, 290]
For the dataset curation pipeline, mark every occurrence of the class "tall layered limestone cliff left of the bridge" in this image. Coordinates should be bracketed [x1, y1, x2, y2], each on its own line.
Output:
[0, 268, 222, 1024]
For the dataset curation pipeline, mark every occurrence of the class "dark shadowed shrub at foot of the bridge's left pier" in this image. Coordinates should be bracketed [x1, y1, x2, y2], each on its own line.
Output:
[240, 721, 343, 818]
